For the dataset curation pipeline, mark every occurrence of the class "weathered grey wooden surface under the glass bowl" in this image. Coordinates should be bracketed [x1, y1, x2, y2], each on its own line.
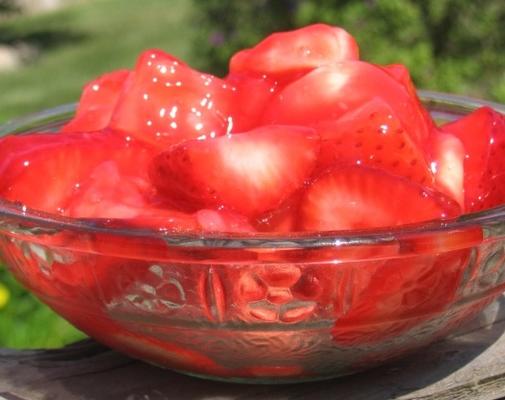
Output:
[0, 295, 505, 400]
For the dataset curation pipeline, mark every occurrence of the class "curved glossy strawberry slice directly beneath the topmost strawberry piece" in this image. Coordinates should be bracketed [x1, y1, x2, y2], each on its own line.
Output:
[263, 61, 431, 145]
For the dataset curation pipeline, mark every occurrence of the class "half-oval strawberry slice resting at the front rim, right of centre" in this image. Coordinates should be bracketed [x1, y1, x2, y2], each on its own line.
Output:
[300, 166, 460, 231]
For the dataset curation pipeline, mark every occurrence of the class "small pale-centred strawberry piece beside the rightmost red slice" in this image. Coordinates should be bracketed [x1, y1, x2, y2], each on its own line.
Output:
[429, 130, 465, 209]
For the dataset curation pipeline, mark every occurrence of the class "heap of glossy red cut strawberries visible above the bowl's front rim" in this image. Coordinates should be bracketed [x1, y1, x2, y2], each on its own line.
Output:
[0, 24, 505, 233]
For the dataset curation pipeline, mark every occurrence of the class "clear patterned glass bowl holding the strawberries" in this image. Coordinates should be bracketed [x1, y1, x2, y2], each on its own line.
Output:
[0, 92, 505, 383]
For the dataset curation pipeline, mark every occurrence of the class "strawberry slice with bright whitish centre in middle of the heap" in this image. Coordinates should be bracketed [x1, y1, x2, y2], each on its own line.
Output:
[150, 126, 319, 217]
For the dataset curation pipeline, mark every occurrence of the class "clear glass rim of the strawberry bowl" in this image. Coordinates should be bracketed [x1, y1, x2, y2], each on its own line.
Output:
[0, 90, 505, 250]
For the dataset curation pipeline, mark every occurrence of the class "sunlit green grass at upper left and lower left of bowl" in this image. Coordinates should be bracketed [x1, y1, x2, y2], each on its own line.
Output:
[0, 0, 199, 348]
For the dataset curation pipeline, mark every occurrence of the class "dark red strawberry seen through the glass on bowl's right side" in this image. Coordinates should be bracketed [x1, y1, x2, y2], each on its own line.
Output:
[332, 249, 470, 346]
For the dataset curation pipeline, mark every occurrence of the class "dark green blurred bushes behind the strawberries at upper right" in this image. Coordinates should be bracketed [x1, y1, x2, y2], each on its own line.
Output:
[194, 0, 505, 102]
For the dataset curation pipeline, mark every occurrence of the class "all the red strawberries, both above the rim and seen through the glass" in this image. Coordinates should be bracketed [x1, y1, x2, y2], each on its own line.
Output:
[0, 24, 505, 377]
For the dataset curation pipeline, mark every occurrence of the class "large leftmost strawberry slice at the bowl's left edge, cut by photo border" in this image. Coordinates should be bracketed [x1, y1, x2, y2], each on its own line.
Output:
[0, 132, 152, 215]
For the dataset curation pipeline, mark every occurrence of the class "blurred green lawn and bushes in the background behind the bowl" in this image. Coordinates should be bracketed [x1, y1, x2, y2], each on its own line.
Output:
[0, 0, 505, 348]
